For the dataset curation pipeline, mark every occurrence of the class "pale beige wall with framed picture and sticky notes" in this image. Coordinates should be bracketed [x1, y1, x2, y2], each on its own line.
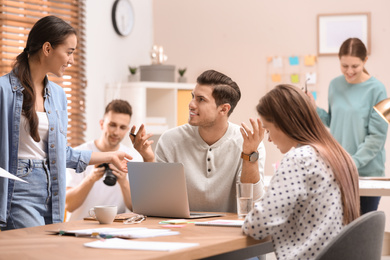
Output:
[153, 0, 390, 229]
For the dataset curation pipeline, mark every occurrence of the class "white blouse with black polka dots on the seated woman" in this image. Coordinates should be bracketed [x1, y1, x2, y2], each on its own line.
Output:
[242, 145, 343, 260]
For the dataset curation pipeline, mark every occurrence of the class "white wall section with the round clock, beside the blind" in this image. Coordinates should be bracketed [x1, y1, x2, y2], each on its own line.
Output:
[86, 0, 153, 140]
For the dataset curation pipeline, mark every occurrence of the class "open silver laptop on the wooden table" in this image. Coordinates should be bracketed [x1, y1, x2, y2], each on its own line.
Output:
[127, 162, 223, 218]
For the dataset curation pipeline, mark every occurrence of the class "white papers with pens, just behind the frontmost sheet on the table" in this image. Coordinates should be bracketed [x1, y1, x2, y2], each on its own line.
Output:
[53, 227, 180, 238]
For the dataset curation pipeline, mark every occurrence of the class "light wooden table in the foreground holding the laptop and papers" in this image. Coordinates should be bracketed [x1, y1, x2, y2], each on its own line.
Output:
[0, 213, 273, 260]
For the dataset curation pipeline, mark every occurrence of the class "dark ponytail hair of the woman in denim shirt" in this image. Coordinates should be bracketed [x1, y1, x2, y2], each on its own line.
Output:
[12, 15, 76, 142]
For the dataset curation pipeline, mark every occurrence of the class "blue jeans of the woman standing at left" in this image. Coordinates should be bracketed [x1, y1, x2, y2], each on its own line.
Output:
[2, 159, 53, 230]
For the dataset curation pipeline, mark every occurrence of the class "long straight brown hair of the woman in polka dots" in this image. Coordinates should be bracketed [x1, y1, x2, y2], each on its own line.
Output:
[256, 84, 360, 224]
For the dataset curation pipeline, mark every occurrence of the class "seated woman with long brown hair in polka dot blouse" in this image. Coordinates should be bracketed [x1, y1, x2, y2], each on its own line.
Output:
[242, 85, 360, 260]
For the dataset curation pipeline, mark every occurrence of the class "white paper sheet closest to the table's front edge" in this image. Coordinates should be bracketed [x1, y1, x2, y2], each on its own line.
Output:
[84, 238, 199, 251]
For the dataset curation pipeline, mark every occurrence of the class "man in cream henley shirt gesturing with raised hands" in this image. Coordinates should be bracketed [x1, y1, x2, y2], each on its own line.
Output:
[131, 70, 265, 213]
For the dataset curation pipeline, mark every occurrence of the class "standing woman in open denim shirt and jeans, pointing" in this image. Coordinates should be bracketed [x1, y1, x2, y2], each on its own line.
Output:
[0, 16, 131, 230]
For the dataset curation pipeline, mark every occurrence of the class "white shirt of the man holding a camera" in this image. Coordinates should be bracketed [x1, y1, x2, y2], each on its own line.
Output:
[66, 141, 143, 221]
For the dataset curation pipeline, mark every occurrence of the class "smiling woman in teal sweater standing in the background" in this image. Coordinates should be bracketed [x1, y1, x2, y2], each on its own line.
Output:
[310, 38, 388, 214]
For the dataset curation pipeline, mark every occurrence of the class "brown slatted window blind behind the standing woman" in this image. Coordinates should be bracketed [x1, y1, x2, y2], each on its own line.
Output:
[0, 0, 87, 147]
